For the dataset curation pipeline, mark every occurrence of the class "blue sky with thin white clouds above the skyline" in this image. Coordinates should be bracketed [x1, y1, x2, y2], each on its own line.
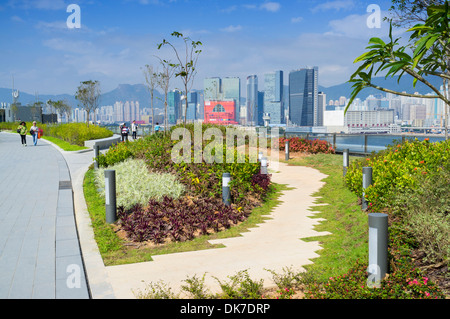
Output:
[0, 0, 400, 95]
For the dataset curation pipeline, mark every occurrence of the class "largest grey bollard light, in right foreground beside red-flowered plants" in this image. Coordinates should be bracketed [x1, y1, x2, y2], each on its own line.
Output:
[367, 213, 389, 287]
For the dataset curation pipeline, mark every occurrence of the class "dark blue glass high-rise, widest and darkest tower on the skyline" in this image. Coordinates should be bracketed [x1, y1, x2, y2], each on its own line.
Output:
[289, 67, 323, 126]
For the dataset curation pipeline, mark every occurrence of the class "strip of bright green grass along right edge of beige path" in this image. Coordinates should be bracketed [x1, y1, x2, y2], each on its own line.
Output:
[288, 154, 368, 280]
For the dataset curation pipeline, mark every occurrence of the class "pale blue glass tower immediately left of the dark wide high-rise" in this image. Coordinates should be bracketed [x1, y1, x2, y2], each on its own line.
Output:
[264, 71, 284, 124]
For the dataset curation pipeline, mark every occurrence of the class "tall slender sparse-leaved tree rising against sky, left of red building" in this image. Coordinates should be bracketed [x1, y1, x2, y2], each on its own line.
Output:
[158, 31, 202, 125]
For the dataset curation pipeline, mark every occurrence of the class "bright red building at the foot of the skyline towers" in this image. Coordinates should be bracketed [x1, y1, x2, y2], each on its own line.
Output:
[204, 101, 238, 125]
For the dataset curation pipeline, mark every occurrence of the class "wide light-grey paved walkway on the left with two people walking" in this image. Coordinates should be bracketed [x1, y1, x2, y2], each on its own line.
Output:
[0, 133, 90, 299]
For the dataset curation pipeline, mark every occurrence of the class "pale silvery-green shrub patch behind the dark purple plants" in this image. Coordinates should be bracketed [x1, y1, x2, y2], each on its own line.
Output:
[95, 159, 185, 209]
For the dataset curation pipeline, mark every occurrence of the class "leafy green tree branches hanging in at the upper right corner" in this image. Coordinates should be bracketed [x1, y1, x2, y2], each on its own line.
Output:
[345, 1, 450, 140]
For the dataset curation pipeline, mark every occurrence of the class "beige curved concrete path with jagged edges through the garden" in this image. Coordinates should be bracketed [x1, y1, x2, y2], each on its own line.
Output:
[106, 159, 328, 298]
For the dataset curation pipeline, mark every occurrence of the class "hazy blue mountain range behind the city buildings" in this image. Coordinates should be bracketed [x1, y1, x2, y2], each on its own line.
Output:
[0, 75, 442, 108]
